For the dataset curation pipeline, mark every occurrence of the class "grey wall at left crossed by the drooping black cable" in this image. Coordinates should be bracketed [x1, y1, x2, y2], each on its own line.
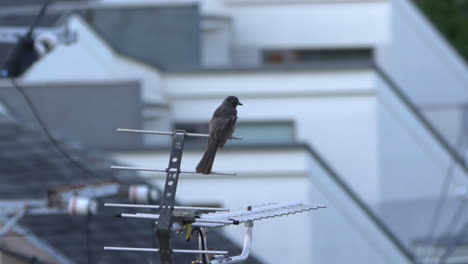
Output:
[0, 82, 143, 149]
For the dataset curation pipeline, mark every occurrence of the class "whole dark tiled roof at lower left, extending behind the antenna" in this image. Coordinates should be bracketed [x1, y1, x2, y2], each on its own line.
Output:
[0, 112, 261, 264]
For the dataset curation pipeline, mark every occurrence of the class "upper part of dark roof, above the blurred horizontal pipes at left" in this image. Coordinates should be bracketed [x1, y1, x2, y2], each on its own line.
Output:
[0, 114, 128, 199]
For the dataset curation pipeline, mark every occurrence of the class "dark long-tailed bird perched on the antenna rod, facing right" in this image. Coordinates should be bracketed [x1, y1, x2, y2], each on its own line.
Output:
[196, 96, 243, 174]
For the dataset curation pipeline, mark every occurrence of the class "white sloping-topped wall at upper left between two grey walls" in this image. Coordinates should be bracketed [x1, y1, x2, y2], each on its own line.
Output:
[24, 16, 166, 103]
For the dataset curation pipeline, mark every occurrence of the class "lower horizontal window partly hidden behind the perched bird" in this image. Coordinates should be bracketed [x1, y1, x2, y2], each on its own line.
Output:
[175, 121, 295, 145]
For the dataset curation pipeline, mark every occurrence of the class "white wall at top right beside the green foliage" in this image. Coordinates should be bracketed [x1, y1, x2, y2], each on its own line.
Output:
[381, 0, 468, 104]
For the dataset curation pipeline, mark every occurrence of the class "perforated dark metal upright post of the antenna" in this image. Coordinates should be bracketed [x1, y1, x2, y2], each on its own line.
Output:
[157, 130, 185, 264]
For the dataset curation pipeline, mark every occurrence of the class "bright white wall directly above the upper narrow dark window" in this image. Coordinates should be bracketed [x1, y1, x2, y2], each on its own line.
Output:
[226, 1, 390, 60]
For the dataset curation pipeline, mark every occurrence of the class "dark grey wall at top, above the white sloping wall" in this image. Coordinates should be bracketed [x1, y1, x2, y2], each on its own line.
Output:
[86, 4, 201, 67]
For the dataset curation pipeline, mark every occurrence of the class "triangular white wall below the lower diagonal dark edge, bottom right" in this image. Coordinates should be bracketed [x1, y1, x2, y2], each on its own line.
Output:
[308, 155, 411, 264]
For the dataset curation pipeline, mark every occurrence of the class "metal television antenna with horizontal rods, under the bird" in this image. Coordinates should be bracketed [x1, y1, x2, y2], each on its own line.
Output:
[104, 128, 326, 264]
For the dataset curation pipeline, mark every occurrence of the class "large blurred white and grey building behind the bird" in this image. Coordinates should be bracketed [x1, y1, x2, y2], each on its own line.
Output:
[0, 0, 468, 263]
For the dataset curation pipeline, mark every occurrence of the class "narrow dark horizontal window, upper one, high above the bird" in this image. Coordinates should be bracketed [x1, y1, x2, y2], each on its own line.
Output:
[263, 48, 373, 65]
